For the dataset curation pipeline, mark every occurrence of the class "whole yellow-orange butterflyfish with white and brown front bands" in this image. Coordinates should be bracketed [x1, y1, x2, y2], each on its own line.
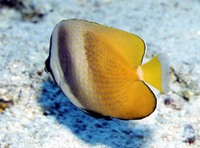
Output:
[45, 19, 169, 120]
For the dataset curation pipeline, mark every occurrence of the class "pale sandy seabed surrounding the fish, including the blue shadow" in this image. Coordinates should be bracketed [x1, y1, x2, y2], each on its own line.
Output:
[0, 0, 200, 148]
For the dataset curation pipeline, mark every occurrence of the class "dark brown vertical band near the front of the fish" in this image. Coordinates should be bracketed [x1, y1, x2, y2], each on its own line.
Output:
[58, 26, 79, 98]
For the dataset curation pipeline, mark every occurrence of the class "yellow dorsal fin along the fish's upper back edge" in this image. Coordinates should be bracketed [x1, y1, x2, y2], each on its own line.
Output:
[69, 20, 145, 67]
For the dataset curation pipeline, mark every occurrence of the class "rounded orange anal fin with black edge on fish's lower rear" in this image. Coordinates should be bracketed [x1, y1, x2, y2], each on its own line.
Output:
[89, 81, 156, 120]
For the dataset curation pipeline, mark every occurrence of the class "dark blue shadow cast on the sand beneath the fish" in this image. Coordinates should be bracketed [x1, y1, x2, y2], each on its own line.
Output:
[38, 81, 151, 148]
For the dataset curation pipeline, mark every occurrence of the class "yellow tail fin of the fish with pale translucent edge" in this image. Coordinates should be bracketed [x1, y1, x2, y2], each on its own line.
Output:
[138, 53, 169, 93]
